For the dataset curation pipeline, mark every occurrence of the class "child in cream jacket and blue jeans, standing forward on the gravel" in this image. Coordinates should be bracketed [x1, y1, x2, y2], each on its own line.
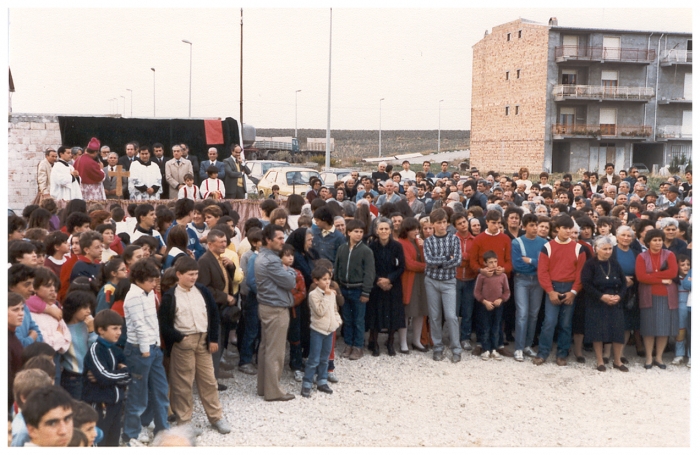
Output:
[301, 267, 342, 398]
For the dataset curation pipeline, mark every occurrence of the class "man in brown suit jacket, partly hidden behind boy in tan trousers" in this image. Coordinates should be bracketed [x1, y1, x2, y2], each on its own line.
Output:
[197, 229, 236, 386]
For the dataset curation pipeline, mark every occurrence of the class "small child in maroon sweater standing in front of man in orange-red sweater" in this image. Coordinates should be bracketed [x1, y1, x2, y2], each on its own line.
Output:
[474, 250, 510, 360]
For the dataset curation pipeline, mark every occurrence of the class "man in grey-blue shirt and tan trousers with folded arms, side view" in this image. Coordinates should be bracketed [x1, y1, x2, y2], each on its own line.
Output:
[254, 224, 296, 401]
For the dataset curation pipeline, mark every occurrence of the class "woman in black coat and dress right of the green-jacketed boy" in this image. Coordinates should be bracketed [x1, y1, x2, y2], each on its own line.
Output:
[365, 218, 406, 357]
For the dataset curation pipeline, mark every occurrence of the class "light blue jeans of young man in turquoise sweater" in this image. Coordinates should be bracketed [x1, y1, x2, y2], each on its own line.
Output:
[513, 273, 544, 351]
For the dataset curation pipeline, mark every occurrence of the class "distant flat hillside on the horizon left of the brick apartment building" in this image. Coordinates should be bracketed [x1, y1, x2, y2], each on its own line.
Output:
[256, 128, 469, 164]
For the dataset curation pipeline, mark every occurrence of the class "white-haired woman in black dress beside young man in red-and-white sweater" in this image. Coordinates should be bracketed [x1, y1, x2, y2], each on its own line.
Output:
[581, 237, 629, 373]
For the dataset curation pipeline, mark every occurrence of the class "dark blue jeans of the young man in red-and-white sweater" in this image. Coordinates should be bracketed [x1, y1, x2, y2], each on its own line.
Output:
[537, 281, 574, 359]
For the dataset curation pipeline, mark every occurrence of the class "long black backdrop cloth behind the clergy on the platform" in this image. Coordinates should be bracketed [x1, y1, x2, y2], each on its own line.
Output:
[58, 116, 241, 160]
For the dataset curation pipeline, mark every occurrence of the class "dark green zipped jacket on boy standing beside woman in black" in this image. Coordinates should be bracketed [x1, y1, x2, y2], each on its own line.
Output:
[333, 242, 374, 297]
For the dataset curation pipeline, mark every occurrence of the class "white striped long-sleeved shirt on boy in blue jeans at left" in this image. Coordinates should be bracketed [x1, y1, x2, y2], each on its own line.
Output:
[124, 284, 160, 353]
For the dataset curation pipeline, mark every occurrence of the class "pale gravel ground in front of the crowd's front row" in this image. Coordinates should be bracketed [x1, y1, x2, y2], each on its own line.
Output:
[180, 335, 690, 447]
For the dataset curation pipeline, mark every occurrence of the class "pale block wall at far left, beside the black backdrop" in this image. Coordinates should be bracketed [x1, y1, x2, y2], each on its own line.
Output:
[7, 114, 61, 211]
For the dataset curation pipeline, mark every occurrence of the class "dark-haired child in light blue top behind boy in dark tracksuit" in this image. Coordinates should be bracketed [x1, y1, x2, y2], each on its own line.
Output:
[61, 291, 97, 400]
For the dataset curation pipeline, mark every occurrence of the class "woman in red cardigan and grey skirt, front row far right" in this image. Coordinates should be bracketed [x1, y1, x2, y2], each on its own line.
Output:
[634, 229, 678, 370]
